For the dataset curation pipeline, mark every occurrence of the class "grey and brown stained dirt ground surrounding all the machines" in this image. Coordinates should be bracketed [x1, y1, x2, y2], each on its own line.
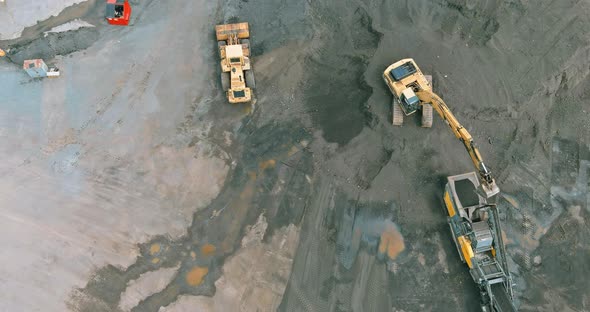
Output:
[0, 0, 590, 312]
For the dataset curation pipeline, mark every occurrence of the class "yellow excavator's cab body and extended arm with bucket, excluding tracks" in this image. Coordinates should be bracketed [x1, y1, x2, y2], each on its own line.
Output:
[383, 58, 500, 199]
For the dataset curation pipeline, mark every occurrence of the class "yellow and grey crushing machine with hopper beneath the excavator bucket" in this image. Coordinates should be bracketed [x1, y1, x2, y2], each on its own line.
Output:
[444, 172, 516, 312]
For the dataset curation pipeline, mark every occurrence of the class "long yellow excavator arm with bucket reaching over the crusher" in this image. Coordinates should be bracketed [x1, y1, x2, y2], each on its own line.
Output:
[416, 90, 500, 199]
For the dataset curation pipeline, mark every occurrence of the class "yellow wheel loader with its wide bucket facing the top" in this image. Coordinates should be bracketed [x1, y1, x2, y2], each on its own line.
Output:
[215, 23, 256, 103]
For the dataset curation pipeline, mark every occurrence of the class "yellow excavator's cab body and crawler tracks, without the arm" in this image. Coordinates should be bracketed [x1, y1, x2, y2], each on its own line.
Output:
[383, 59, 432, 128]
